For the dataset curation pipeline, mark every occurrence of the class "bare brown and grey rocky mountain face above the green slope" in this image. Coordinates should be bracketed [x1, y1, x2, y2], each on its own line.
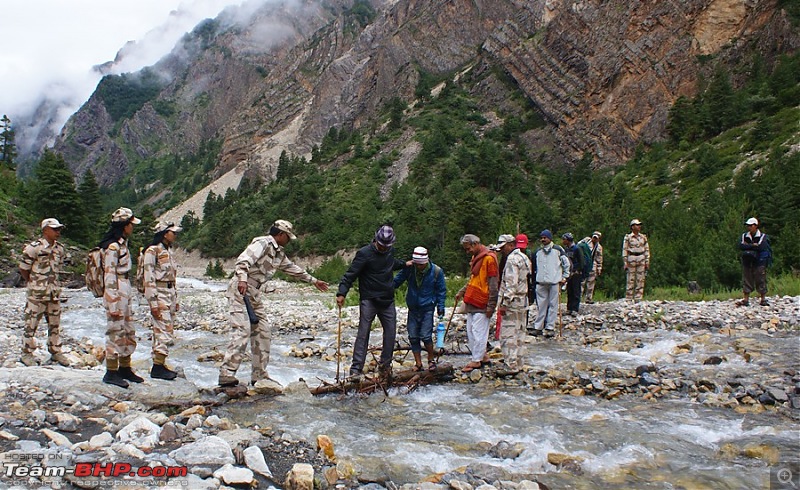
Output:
[57, 0, 800, 184]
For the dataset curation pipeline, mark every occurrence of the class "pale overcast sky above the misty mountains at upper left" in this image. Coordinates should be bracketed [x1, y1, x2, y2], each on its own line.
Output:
[0, 0, 241, 153]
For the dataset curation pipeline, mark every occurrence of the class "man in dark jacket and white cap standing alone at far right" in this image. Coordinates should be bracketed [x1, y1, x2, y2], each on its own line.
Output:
[737, 218, 772, 306]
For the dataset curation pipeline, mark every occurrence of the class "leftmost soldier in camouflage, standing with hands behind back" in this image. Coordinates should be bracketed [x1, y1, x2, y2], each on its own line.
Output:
[19, 218, 69, 366]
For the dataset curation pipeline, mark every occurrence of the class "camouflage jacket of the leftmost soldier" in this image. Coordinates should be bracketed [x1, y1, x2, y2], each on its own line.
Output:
[19, 238, 66, 298]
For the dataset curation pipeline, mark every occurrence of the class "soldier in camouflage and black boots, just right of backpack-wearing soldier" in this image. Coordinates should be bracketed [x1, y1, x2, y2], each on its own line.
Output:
[144, 223, 183, 380]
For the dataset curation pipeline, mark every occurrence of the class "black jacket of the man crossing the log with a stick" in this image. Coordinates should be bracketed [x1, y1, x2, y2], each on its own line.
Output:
[336, 243, 406, 302]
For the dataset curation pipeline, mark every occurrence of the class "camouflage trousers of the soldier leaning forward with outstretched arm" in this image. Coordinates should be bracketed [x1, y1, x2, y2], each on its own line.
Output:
[219, 284, 272, 383]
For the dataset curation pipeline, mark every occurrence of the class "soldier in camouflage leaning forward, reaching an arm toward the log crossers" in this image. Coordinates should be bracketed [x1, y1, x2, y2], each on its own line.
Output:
[218, 220, 328, 386]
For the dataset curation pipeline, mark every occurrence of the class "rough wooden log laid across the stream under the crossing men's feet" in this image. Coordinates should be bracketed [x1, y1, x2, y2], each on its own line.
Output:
[311, 364, 454, 395]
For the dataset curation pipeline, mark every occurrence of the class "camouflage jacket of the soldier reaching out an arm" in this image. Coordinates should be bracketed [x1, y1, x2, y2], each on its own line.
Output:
[233, 236, 317, 288]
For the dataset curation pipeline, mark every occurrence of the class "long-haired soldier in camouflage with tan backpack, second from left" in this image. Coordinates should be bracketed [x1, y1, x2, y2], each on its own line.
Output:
[100, 208, 144, 388]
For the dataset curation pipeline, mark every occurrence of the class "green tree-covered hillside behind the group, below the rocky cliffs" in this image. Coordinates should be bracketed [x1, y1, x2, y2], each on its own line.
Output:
[182, 54, 800, 294]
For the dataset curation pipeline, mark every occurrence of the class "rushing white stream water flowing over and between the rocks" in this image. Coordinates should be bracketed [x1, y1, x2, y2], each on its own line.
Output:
[54, 280, 800, 489]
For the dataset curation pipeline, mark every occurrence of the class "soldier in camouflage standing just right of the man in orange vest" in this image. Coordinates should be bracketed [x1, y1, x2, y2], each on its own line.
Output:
[497, 235, 532, 375]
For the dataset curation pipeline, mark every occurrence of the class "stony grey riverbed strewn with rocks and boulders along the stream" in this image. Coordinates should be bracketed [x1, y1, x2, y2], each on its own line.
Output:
[0, 281, 800, 490]
